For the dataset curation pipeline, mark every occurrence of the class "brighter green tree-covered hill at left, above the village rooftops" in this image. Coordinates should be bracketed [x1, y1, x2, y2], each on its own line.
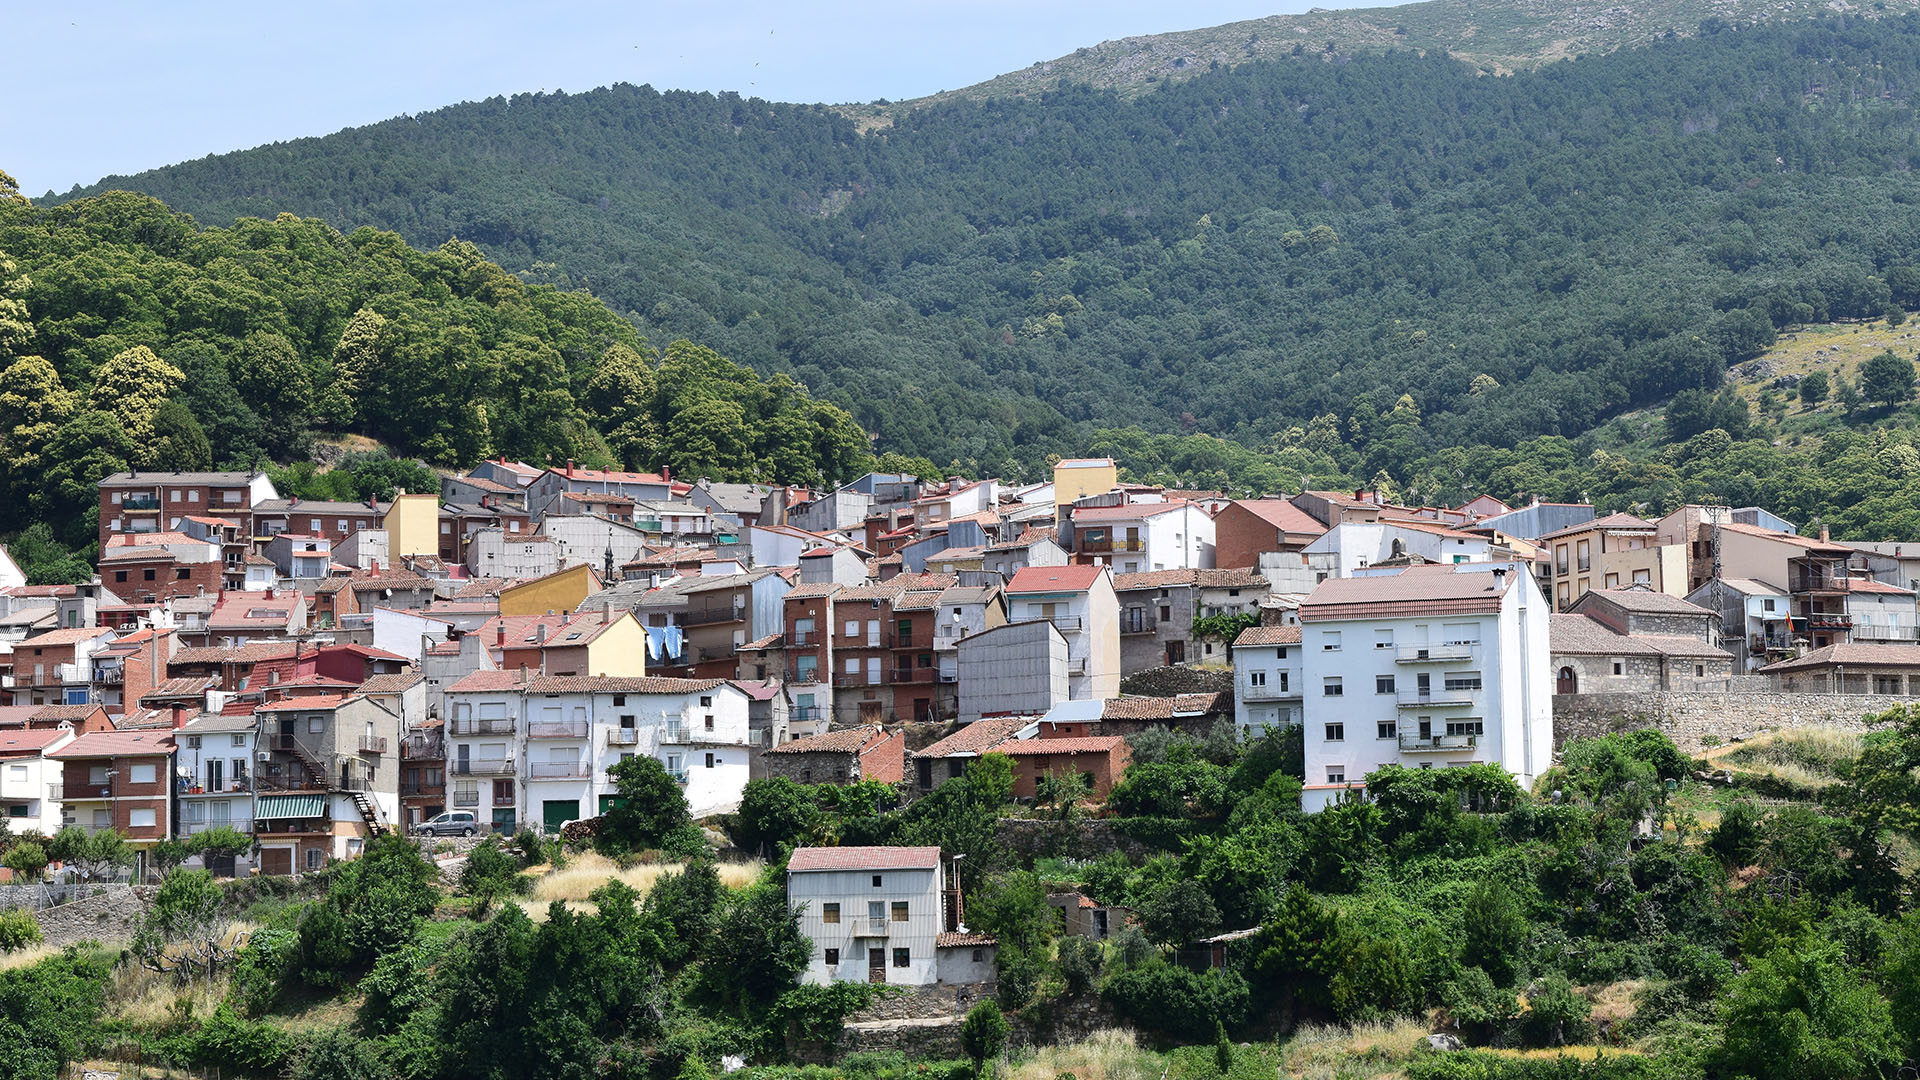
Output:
[0, 173, 868, 540]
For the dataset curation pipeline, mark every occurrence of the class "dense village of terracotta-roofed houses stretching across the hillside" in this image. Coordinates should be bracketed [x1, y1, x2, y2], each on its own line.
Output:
[0, 459, 1920, 880]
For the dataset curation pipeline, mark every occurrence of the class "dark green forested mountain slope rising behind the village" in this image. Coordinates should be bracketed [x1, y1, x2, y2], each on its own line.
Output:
[45, 17, 1920, 478]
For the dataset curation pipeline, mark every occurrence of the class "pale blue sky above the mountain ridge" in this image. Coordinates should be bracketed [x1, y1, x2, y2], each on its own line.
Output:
[0, 0, 1380, 196]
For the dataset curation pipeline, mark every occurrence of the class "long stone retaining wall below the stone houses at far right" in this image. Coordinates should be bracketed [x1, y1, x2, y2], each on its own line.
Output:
[1553, 690, 1912, 753]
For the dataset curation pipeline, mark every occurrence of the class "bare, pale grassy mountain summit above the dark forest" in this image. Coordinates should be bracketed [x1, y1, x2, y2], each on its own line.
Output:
[860, 0, 1920, 123]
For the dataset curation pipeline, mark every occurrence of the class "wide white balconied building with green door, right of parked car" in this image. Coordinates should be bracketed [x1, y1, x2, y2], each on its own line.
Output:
[445, 671, 751, 832]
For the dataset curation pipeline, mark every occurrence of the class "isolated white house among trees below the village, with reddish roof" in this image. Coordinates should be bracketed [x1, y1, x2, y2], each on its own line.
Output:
[787, 847, 995, 986]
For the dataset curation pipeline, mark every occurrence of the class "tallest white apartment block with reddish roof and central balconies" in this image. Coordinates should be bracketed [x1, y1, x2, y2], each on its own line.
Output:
[1282, 563, 1553, 811]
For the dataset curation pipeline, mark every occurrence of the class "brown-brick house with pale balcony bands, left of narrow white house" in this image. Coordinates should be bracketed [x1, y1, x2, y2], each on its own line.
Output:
[46, 728, 175, 882]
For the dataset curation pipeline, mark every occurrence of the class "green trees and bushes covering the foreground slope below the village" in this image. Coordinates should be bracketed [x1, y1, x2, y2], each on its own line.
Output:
[0, 709, 1920, 1080]
